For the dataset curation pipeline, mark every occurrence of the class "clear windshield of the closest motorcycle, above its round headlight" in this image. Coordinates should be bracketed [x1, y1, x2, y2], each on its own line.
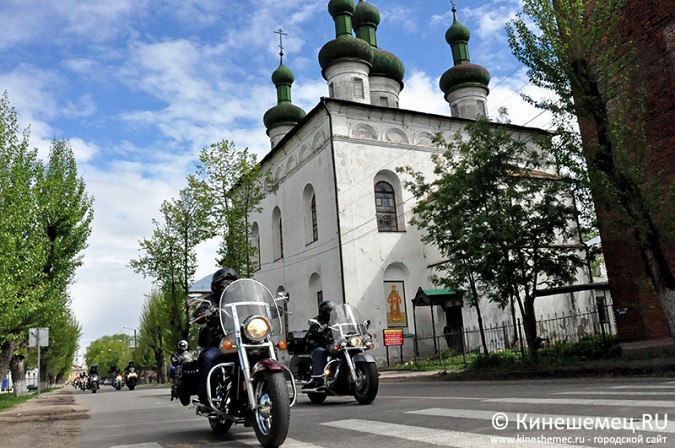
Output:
[220, 278, 284, 340]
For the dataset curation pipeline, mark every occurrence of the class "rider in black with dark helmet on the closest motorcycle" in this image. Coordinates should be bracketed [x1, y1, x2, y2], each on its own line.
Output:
[194, 267, 239, 405]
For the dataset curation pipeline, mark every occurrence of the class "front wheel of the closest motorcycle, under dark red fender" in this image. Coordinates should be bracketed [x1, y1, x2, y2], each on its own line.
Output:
[252, 372, 291, 448]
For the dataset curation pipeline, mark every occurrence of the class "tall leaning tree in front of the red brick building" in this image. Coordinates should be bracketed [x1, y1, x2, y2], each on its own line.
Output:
[507, 0, 675, 334]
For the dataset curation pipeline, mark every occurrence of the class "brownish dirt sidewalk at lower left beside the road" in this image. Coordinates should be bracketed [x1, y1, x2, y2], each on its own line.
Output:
[0, 387, 89, 448]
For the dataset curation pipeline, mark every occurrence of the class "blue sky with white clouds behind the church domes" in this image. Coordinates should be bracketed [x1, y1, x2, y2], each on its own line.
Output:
[0, 0, 549, 356]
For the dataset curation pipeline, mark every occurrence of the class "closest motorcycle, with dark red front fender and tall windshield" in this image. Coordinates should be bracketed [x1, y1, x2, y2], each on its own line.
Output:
[171, 279, 297, 447]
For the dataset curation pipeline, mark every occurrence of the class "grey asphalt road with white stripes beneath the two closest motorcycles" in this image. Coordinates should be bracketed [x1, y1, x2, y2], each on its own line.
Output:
[76, 378, 675, 448]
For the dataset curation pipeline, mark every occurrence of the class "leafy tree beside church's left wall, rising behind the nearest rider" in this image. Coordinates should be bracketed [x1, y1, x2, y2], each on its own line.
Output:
[188, 140, 271, 277]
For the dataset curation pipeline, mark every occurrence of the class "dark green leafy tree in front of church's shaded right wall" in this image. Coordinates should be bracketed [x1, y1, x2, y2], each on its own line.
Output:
[403, 118, 584, 361]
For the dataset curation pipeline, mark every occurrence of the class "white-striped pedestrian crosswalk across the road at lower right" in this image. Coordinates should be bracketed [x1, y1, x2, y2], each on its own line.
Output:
[105, 381, 675, 448]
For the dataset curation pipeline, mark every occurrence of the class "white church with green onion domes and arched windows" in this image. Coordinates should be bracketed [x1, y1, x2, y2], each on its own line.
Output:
[249, 0, 594, 363]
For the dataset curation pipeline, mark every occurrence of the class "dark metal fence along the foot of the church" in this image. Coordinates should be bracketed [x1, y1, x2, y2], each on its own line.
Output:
[415, 305, 616, 363]
